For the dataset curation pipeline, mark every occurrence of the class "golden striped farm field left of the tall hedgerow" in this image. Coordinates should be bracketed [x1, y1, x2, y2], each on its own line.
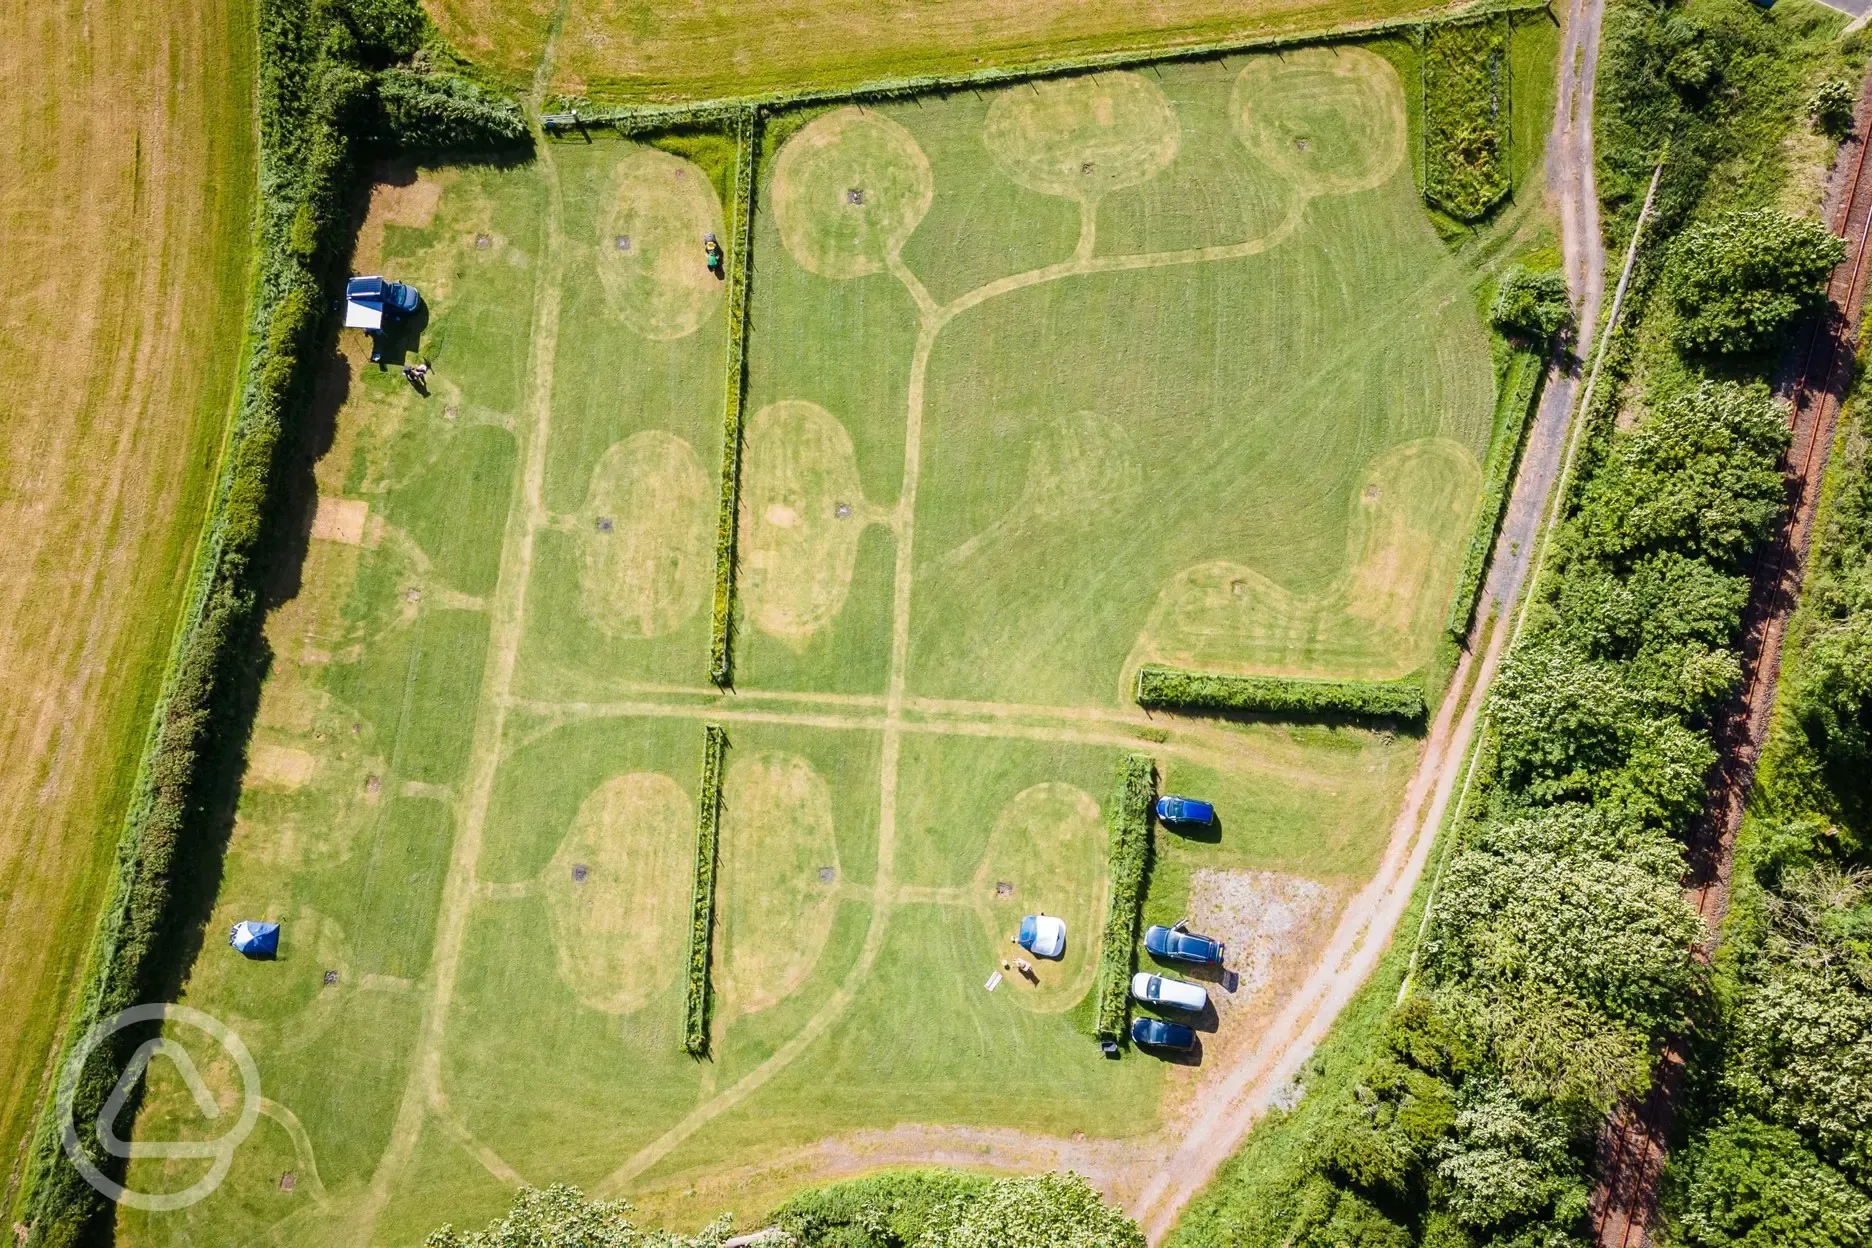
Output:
[0, 0, 255, 1207]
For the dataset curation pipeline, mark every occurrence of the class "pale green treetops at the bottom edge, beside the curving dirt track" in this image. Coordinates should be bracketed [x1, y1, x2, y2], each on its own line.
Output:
[775, 1169, 1144, 1248]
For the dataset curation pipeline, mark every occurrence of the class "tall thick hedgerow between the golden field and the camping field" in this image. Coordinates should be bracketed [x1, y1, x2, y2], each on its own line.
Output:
[21, 0, 526, 1248]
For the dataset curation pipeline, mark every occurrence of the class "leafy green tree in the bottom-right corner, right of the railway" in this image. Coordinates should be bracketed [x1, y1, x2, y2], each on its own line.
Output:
[1679, 1115, 1872, 1248]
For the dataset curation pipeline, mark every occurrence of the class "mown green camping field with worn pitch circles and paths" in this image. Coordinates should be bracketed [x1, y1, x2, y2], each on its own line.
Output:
[120, 34, 1494, 1244]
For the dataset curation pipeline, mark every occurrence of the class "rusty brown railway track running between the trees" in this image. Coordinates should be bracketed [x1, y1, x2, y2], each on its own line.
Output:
[1589, 75, 1872, 1248]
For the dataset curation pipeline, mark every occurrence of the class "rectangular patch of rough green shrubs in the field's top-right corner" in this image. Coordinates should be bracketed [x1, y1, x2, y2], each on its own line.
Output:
[1423, 15, 1511, 221]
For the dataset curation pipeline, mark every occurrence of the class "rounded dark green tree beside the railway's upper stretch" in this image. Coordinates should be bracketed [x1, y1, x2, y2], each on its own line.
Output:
[1666, 208, 1846, 356]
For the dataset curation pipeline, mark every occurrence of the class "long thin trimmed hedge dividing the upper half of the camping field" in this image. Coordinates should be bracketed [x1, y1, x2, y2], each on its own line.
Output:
[708, 109, 760, 687]
